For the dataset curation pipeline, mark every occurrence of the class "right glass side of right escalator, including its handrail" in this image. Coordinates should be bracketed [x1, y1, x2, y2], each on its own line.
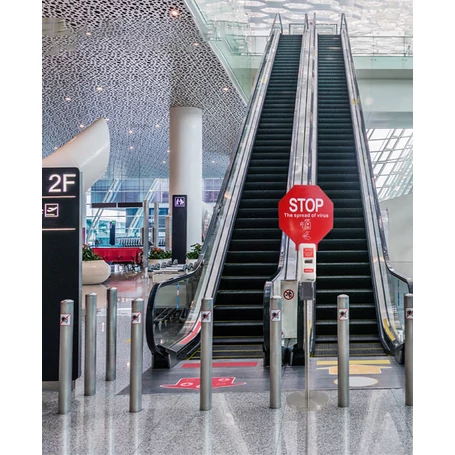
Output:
[340, 14, 412, 362]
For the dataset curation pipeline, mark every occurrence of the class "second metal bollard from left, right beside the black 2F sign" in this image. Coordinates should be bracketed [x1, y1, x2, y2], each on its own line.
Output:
[84, 292, 96, 396]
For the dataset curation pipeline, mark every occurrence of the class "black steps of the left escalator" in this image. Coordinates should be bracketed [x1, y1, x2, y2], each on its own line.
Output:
[192, 35, 302, 359]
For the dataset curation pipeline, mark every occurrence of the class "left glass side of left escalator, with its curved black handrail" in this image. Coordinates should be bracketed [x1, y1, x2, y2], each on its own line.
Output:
[146, 16, 282, 367]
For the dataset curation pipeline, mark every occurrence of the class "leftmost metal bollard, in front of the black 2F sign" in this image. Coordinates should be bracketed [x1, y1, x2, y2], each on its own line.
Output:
[58, 299, 74, 414]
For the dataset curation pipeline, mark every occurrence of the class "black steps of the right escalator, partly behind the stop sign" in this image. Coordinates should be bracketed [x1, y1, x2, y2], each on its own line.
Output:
[314, 35, 385, 357]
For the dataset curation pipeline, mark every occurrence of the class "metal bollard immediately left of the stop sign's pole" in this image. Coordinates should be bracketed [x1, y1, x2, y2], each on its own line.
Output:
[270, 295, 282, 409]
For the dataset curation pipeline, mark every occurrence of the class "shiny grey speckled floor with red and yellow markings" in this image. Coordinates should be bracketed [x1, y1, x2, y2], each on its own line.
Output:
[43, 273, 416, 455]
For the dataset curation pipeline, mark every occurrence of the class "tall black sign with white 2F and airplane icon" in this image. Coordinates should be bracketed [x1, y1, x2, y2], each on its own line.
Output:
[42, 167, 82, 381]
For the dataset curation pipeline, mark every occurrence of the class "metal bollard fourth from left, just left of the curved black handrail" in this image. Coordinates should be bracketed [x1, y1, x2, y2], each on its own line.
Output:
[130, 299, 144, 412]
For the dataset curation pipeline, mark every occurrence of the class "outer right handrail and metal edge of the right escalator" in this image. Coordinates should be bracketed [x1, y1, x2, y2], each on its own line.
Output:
[340, 14, 412, 358]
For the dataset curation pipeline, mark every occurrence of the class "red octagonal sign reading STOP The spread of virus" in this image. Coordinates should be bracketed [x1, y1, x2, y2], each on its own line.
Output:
[278, 185, 333, 248]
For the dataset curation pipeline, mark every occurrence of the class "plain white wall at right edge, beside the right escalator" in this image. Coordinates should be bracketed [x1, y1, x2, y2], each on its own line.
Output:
[379, 193, 413, 278]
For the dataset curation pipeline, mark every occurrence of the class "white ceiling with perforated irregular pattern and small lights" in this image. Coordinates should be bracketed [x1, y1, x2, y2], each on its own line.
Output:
[42, 0, 412, 179]
